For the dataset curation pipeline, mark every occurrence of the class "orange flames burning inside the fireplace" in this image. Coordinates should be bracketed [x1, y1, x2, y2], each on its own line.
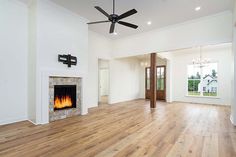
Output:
[54, 96, 72, 109]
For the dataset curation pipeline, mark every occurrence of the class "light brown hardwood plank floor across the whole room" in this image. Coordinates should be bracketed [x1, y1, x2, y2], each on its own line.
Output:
[0, 100, 236, 157]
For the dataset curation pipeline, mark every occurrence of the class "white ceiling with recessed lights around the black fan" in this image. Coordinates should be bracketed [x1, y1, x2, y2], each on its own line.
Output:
[51, 0, 233, 38]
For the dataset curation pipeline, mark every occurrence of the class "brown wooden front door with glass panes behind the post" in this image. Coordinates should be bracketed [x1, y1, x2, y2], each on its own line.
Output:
[145, 66, 166, 100]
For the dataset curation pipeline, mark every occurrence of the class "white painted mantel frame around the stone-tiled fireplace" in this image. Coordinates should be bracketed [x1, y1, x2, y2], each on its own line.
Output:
[37, 70, 88, 125]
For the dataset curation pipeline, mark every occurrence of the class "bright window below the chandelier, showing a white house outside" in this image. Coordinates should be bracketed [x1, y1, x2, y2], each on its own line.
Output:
[188, 63, 218, 97]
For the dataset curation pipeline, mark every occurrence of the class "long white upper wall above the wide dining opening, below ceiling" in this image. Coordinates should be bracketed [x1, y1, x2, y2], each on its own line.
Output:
[113, 11, 232, 57]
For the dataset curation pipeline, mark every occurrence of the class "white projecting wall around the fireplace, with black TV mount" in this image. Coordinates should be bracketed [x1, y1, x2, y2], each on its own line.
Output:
[29, 0, 89, 124]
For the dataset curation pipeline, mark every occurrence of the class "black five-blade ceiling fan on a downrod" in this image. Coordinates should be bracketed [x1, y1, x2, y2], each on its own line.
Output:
[88, 0, 138, 33]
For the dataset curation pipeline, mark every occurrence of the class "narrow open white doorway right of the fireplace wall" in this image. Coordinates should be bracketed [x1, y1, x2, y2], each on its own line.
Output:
[98, 59, 110, 105]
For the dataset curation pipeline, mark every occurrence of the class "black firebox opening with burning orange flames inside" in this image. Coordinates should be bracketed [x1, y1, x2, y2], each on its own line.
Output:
[54, 85, 76, 111]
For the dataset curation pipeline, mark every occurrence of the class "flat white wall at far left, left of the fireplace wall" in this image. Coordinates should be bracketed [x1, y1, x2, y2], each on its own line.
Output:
[0, 0, 27, 125]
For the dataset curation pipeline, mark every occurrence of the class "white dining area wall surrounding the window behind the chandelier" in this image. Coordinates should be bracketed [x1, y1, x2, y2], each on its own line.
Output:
[163, 44, 232, 105]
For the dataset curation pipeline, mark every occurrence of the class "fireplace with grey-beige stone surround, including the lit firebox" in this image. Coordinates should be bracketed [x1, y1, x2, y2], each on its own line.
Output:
[49, 76, 82, 122]
